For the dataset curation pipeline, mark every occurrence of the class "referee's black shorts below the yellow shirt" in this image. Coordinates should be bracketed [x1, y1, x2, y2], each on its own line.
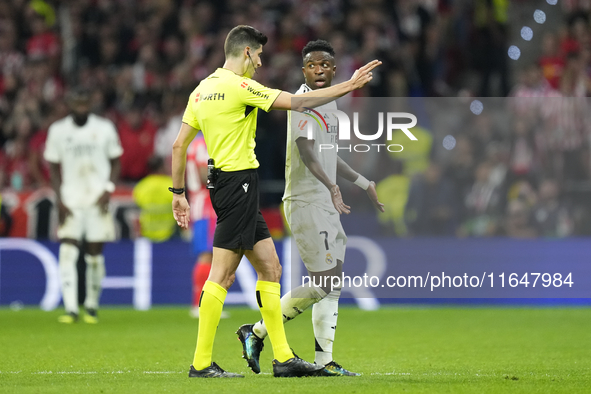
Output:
[209, 169, 271, 250]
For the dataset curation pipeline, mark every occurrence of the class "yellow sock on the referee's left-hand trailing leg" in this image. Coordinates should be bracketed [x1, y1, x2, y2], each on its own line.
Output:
[193, 281, 227, 370]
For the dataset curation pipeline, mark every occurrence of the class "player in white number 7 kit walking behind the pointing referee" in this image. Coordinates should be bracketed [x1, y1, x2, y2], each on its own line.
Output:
[237, 40, 384, 376]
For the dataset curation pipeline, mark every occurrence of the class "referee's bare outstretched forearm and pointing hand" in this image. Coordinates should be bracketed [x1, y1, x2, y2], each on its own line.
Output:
[271, 60, 382, 112]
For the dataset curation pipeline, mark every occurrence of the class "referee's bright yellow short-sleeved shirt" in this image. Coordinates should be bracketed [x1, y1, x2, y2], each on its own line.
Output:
[183, 68, 281, 171]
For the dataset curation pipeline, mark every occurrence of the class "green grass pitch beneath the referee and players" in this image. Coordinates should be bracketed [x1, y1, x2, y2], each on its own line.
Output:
[0, 307, 591, 394]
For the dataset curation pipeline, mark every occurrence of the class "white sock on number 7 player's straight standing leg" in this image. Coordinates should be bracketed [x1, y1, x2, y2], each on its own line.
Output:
[312, 289, 341, 365]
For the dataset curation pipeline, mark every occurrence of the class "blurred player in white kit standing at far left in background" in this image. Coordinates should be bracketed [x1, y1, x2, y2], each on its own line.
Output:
[44, 89, 123, 323]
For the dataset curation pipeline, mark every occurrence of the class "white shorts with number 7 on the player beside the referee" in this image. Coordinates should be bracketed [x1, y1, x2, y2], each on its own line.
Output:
[285, 201, 347, 272]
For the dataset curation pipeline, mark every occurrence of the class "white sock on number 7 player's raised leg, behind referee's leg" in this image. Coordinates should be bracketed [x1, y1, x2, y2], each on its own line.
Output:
[252, 285, 326, 339]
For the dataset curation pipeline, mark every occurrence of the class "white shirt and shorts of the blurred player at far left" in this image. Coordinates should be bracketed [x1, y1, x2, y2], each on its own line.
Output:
[44, 114, 123, 242]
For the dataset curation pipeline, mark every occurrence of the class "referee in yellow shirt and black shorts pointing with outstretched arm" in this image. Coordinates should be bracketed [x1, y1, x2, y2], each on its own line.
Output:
[170, 25, 381, 378]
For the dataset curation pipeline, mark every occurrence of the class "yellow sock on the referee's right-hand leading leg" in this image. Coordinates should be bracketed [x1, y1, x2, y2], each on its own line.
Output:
[256, 280, 293, 368]
